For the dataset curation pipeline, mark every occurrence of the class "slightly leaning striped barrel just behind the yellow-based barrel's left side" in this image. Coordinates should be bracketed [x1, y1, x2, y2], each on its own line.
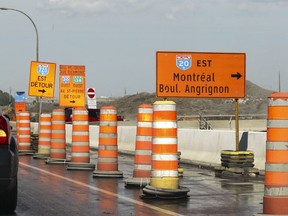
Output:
[125, 104, 153, 186]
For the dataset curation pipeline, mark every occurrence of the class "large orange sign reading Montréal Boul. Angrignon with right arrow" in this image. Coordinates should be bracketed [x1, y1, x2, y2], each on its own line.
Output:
[156, 51, 246, 98]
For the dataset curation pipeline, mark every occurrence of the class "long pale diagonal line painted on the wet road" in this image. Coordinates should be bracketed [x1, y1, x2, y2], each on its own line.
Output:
[19, 162, 184, 216]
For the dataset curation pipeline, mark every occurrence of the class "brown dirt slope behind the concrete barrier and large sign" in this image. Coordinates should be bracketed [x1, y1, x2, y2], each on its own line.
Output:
[98, 81, 271, 120]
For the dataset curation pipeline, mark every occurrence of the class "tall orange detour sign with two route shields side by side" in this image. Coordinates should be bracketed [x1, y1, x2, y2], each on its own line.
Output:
[59, 65, 86, 107]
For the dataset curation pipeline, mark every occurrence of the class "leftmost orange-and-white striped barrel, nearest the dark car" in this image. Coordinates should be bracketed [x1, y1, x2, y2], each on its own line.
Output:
[17, 111, 33, 154]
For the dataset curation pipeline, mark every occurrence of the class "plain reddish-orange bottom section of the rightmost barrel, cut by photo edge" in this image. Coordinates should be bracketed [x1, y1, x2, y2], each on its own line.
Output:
[263, 196, 288, 215]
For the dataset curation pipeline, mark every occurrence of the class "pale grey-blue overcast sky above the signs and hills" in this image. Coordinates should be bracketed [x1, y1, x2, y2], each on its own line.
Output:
[0, 0, 288, 97]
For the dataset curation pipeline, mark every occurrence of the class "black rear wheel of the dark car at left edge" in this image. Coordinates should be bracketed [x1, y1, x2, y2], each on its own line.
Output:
[0, 178, 18, 214]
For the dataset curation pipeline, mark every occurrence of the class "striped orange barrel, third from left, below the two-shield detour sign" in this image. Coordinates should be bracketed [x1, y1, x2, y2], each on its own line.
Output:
[46, 109, 66, 163]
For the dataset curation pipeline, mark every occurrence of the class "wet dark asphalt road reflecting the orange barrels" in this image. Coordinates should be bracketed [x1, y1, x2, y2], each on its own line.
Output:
[3, 155, 264, 216]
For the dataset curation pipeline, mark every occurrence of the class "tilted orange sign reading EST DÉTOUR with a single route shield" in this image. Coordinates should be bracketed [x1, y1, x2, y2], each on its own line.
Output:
[28, 61, 56, 98]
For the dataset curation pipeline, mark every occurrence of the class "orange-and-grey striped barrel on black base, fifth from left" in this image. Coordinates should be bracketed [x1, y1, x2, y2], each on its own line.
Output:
[93, 106, 123, 177]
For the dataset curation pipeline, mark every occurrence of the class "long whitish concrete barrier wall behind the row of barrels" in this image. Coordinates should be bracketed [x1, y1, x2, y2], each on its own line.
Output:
[31, 123, 266, 170]
